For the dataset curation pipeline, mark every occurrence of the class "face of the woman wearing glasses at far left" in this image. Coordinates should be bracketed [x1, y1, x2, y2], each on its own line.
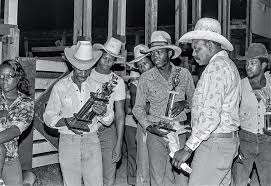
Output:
[0, 65, 18, 93]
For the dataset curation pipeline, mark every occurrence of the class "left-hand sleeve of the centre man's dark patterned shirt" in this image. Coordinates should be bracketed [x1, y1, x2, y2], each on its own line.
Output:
[132, 76, 150, 130]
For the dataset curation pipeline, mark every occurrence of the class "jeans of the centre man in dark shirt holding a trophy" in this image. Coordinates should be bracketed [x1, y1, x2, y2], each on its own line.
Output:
[147, 132, 188, 186]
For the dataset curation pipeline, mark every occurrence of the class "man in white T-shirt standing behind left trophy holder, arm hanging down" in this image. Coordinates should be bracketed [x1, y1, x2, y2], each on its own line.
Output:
[90, 37, 126, 186]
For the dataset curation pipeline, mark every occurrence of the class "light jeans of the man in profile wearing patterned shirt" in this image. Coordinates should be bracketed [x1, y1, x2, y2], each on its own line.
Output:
[188, 134, 239, 186]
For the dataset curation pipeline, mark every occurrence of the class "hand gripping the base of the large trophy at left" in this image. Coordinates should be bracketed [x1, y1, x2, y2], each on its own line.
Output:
[66, 117, 90, 134]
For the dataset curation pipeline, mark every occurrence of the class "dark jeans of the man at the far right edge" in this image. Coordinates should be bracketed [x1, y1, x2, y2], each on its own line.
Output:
[233, 129, 271, 186]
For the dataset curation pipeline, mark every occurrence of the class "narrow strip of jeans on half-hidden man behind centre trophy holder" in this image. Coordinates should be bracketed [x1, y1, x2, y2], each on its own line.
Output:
[136, 125, 150, 186]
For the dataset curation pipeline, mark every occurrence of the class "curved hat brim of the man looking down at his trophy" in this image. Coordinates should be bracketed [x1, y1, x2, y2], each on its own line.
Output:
[64, 46, 103, 70]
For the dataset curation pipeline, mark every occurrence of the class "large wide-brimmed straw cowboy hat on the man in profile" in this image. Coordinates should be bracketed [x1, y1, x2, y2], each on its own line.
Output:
[179, 18, 233, 51]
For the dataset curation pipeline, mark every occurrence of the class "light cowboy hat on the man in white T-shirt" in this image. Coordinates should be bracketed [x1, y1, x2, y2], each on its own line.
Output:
[93, 37, 123, 58]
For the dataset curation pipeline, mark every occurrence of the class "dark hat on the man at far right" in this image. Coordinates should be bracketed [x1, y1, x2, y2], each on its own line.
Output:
[237, 43, 271, 61]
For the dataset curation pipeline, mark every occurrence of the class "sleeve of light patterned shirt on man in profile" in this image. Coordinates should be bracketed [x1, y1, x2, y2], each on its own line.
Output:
[186, 61, 225, 150]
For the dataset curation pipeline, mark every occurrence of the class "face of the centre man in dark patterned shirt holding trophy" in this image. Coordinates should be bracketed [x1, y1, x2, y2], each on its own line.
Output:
[151, 48, 169, 68]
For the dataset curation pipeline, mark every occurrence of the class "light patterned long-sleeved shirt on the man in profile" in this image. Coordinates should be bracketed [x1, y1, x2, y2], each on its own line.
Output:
[186, 51, 241, 150]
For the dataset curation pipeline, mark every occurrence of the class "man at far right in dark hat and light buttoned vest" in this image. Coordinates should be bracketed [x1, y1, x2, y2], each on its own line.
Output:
[233, 43, 271, 186]
